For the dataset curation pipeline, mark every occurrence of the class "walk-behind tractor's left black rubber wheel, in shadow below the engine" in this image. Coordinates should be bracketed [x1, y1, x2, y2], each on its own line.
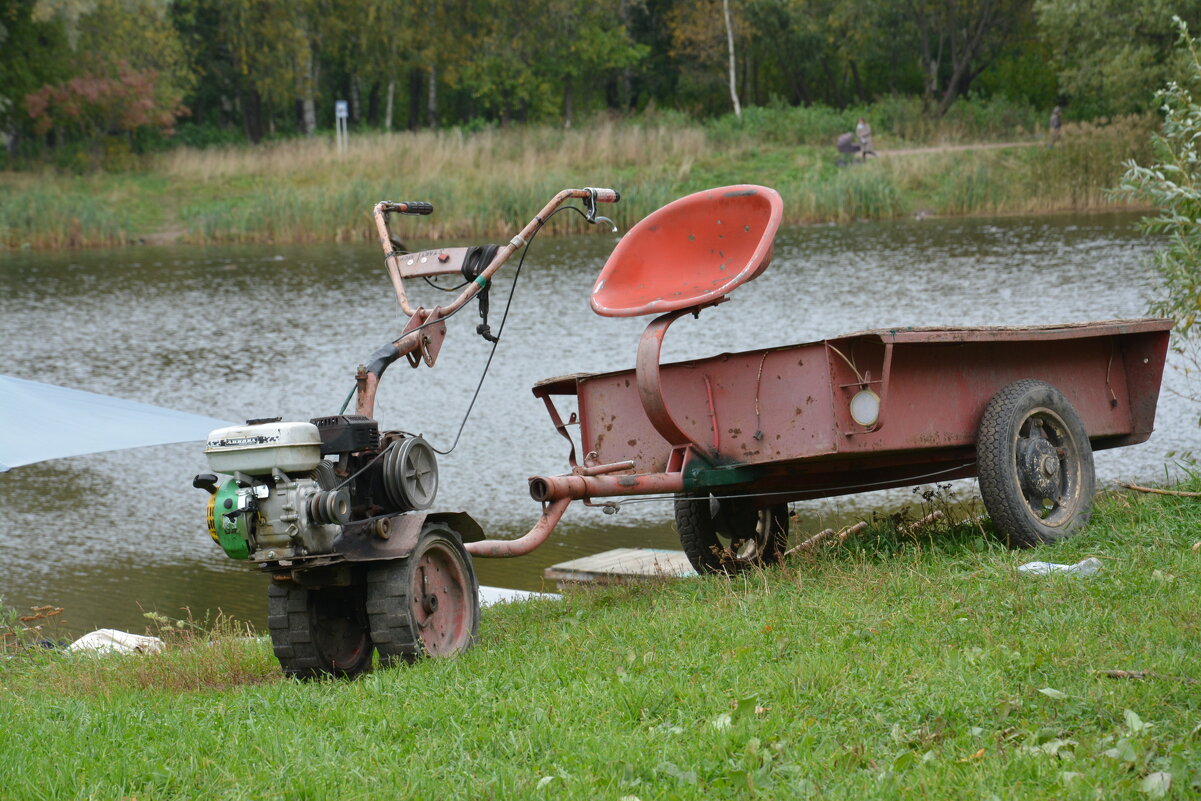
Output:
[267, 581, 375, 679]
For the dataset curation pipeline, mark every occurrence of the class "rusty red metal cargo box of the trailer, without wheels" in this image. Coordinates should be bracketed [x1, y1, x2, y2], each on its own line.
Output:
[555, 319, 1171, 489]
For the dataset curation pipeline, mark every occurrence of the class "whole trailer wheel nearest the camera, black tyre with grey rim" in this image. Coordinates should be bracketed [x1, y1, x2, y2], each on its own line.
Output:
[976, 379, 1095, 548]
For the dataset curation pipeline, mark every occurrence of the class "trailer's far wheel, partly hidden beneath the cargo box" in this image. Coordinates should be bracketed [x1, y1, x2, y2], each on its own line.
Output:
[675, 494, 788, 575]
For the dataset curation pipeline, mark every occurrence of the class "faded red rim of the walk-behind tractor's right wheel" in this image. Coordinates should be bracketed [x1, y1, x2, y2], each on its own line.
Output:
[410, 540, 474, 657]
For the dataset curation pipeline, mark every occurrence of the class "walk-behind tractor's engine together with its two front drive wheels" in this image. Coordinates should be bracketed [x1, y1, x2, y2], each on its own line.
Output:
[193, 416, 483, 679]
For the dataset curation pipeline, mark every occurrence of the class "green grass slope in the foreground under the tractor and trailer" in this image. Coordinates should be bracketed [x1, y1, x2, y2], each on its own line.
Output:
[0, 483, 1201, 801]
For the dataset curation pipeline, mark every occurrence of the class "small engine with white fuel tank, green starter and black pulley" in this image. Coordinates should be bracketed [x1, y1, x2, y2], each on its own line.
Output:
[192, 416, 437, 562]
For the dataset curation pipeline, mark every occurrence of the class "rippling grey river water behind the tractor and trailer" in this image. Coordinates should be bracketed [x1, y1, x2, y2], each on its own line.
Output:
[0, 215, 1186, 632]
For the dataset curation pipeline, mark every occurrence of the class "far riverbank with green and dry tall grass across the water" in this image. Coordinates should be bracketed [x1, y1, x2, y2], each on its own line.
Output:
[0, 116, 1153, 249]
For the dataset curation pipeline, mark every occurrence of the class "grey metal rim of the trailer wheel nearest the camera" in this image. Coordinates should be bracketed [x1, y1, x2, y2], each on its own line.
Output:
[1014, 408, 1082, 527]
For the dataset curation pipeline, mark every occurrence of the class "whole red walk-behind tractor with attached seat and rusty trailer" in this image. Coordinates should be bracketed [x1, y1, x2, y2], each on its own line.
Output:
[197, 185, 1172, 675]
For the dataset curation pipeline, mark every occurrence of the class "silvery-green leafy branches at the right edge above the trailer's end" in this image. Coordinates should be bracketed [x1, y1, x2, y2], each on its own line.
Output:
[1122, 17, 1201, 341]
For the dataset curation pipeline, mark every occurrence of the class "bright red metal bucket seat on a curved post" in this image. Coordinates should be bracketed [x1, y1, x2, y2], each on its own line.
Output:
[592, 184, 784, 317]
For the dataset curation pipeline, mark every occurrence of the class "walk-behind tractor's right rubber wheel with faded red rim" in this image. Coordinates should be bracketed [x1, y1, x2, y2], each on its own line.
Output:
[366, 522, 479, 665]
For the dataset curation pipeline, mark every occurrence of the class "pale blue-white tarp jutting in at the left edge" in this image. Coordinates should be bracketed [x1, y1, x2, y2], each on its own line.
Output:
[0, 376, 234, 472]
